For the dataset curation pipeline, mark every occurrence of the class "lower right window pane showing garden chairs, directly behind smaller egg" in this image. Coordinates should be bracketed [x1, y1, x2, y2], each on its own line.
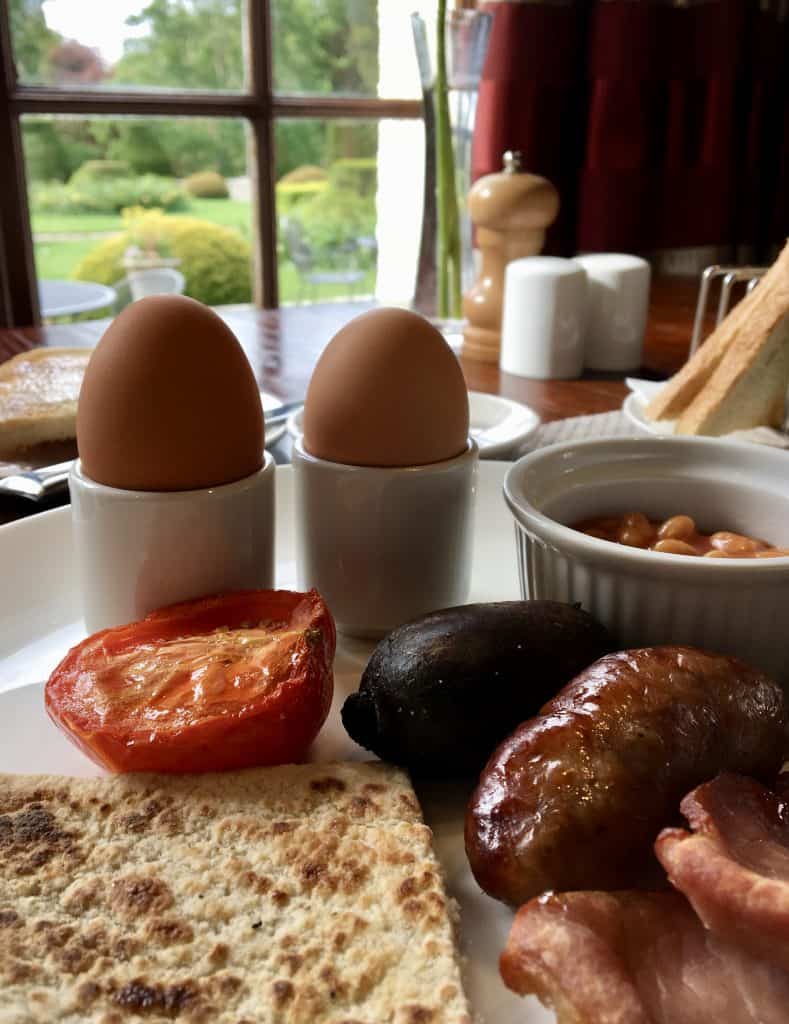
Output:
[275, 119, 424, 303]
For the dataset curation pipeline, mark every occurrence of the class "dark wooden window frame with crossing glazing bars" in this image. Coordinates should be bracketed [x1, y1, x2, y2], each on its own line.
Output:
[0, 0, 422, 327]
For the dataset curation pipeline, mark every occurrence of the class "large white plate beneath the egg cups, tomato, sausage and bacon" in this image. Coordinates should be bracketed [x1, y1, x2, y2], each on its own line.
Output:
[0, 463, 555, 1024]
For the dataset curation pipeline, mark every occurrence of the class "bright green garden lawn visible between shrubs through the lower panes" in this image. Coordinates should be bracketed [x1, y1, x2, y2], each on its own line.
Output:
[32, 199, 376, 302]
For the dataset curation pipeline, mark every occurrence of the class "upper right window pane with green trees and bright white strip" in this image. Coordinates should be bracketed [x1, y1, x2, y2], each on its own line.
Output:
[271, 0, 437, 99]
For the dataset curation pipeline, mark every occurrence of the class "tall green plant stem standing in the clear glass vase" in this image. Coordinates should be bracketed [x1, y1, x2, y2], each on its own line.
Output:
[436, 0, 461, 316]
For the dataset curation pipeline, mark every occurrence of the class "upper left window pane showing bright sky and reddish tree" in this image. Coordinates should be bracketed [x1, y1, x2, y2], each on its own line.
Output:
[8, 0, 245, 90]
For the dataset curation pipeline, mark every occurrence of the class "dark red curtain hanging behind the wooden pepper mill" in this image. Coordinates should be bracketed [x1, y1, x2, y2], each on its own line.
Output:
[473, 0, 789, 262]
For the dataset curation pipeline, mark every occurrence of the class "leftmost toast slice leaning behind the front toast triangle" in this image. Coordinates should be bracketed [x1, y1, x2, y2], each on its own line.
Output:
[645, 242, 789, 423]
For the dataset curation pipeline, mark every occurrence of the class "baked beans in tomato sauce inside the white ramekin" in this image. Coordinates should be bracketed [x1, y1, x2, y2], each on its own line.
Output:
[574, 512, 789, 558]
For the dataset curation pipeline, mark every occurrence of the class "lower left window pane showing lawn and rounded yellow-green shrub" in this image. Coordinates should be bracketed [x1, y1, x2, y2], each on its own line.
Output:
[23, 116, 253, 316]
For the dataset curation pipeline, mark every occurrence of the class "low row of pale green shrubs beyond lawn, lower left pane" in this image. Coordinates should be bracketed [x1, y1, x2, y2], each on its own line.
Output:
[32, 174, 189, 213]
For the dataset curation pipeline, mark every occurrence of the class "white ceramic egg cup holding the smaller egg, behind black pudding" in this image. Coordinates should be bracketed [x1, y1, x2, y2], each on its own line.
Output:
[293, 438, 479, 638]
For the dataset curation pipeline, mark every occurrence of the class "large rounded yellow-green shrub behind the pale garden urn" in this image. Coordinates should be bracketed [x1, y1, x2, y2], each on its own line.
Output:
[72, 210, 252, 305]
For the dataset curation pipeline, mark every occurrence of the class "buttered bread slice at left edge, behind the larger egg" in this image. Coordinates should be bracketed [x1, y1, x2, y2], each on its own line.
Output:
[0, 348, 91, 456]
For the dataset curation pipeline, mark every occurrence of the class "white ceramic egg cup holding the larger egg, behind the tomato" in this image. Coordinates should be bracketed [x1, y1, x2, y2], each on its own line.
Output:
[69, 453, 275, 633]
